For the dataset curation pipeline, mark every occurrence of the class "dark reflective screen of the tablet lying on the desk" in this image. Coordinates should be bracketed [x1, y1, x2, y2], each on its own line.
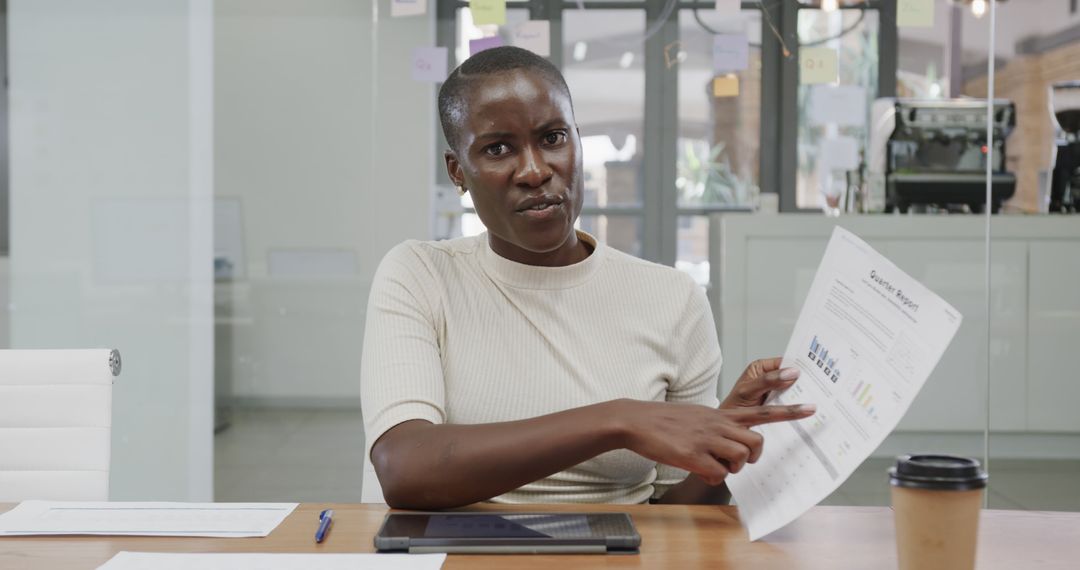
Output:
[380, 513, 634, 539]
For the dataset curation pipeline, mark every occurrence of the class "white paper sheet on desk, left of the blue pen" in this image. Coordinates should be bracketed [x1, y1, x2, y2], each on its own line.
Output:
[0, 501, 296, 538]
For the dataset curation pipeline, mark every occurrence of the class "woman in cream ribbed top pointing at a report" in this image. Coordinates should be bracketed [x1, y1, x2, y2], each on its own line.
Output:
[362, 48, 813, 510]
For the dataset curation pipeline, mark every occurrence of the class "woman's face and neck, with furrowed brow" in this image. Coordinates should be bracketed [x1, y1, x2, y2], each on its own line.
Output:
[446, 70, 586, 266]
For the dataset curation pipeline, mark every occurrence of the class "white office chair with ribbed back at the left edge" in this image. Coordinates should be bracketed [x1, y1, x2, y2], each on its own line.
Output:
[0, 350, 120, 502]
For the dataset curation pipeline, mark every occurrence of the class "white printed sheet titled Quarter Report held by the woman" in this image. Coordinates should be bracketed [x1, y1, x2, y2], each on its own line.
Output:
[728, 228, 962, 540]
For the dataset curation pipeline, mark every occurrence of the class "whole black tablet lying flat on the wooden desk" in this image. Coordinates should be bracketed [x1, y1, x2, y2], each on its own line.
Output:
[375, 513, 642, 554]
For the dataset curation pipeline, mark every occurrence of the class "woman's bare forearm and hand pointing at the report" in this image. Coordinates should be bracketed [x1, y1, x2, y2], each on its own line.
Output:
[372, 399, 814, 508]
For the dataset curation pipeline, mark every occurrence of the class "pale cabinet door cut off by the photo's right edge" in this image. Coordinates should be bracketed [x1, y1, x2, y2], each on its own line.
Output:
[1027, 241, 1080, 432]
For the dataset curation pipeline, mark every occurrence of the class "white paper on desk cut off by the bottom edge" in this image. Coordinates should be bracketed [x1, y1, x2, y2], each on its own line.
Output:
[97, 552, 446, 570]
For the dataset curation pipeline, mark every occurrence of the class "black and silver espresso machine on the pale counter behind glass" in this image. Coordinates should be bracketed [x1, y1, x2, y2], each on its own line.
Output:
[867, 98, 1016, 213]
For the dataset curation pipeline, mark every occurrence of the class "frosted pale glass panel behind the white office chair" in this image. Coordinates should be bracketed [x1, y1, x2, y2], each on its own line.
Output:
[0, 0, 214, 501]
